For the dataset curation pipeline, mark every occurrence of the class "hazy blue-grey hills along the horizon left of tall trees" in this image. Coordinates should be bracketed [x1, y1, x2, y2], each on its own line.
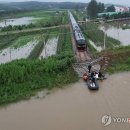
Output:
[0, 1, 87, 16]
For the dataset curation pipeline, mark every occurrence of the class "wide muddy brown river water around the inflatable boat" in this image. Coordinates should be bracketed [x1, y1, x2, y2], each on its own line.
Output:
[0, 72, 130, 130]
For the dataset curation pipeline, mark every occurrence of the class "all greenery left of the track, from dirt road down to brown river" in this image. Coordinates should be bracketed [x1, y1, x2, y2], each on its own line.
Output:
[0, 24, 78, 105]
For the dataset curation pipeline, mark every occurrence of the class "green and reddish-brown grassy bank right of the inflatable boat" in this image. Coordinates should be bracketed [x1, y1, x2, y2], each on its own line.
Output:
[100, 46, 130, 74]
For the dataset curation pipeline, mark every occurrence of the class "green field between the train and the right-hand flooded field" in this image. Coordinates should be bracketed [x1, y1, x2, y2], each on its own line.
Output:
[81, 22, 120, 48]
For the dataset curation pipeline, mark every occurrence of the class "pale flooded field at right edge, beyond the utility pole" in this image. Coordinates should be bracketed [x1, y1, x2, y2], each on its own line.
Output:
[100, 26, 130, 46]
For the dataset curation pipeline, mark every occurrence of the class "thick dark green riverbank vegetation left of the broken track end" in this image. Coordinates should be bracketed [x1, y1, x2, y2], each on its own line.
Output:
[0, 54, 78, 104]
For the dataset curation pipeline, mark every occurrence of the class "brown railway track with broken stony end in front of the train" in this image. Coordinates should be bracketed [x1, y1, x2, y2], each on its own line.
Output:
[70, 11, 100, 77]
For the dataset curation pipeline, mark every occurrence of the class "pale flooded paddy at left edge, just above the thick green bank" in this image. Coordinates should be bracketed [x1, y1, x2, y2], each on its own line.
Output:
[0, 40, 38, 64]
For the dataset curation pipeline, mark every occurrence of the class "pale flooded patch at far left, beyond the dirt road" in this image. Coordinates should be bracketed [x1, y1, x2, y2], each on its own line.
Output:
[0, 17, 36, 27]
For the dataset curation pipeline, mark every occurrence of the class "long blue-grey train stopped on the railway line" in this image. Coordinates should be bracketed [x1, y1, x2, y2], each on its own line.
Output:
[68, 11, 87, 51]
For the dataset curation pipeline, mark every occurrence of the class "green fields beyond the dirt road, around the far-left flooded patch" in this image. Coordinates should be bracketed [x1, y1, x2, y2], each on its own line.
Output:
[1, 10, 68, 32]
